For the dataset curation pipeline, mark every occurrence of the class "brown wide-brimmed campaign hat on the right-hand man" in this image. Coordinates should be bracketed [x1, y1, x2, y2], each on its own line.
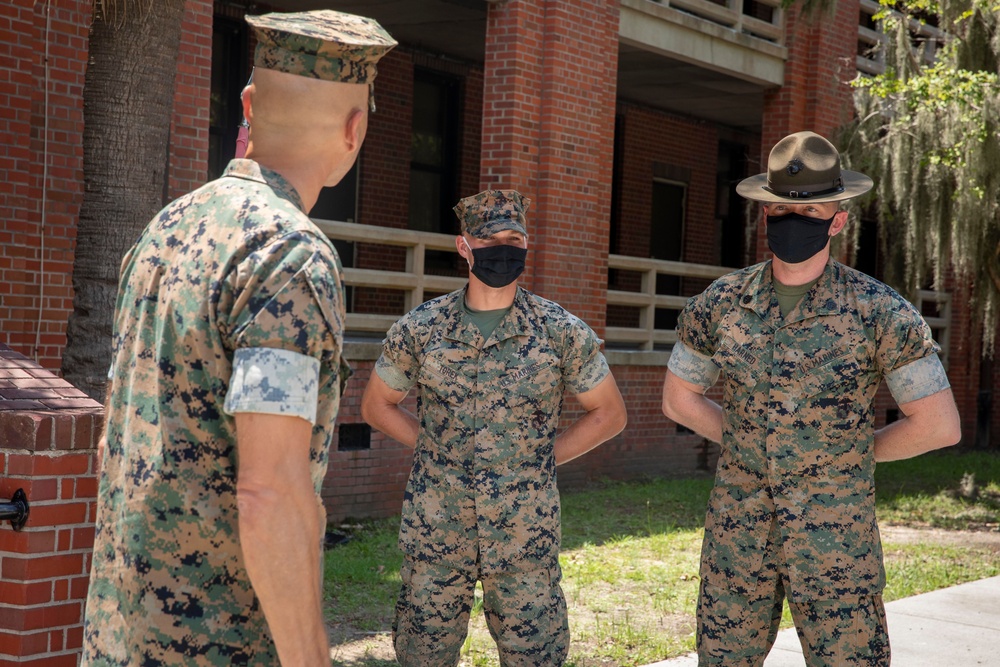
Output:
[736, 132, 873, 203]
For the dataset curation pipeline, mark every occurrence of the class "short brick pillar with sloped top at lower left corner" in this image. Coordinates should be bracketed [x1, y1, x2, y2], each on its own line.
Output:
[0, 345, 103, 667]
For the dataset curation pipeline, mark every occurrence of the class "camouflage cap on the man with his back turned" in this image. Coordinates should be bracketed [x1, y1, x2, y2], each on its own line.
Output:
[247, 9, 396, 84]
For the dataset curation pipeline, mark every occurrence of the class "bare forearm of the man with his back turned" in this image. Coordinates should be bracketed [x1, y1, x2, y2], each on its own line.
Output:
[237, 480, 330, 667]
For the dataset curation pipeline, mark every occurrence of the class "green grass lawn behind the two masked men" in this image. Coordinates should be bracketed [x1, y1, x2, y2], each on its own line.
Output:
[326, 451, 1000, 667]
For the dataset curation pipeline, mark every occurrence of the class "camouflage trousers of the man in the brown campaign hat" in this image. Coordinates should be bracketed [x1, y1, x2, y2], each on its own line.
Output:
[698, 523, 890, 667]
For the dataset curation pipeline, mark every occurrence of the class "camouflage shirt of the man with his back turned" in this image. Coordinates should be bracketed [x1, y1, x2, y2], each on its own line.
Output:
[83, 160, 345, 665]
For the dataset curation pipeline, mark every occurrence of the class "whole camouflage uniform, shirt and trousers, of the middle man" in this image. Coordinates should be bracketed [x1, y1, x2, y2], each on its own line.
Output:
[375, 288, 609, 667]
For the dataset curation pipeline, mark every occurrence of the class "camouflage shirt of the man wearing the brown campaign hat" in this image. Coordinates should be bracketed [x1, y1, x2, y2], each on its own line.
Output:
[670, 261, 949, 601]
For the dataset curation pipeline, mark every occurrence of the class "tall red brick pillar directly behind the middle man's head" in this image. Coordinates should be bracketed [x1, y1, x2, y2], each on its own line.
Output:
[480, 0, 618, 331]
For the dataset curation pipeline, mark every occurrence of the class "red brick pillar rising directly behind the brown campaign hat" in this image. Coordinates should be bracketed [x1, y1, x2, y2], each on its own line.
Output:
[757, 0, 859, 259]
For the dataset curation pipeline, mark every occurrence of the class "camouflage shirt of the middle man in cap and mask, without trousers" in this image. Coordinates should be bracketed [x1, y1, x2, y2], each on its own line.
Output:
[375, 288, 609, 574]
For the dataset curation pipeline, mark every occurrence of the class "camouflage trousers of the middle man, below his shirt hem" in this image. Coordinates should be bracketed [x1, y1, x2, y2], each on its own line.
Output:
[392, 557, 569, 667]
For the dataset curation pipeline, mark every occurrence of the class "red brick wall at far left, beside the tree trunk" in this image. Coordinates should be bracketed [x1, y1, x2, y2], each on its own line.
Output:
[0, 0, 91, 368]
